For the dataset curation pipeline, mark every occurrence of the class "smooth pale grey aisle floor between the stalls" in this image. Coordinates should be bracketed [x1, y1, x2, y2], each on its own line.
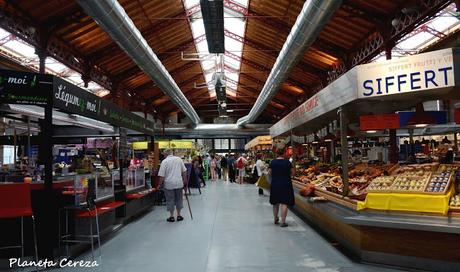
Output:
[61, 182, 402, 272]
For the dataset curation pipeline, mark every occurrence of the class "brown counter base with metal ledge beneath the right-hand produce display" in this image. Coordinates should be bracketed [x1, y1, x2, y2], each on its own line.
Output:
[293, 186, 460, 271]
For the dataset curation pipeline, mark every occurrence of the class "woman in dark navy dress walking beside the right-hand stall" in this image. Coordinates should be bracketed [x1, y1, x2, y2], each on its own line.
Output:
[269, 149, 295, 227]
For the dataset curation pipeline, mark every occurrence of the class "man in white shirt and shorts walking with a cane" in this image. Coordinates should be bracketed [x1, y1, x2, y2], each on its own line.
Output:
[157, 149, 187, 222]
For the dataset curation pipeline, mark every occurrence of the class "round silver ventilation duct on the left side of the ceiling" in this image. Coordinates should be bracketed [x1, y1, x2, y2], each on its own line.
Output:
[78, 0, 200, 124]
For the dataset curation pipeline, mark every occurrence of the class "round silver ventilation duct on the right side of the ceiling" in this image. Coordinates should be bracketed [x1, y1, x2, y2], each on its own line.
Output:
[237, 0, 342, 126]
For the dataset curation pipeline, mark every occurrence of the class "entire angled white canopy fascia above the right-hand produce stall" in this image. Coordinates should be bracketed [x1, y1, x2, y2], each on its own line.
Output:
[270, 48, 460, 137]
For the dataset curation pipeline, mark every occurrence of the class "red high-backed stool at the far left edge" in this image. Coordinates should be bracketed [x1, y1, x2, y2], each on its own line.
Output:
[0, 183, 38, 260]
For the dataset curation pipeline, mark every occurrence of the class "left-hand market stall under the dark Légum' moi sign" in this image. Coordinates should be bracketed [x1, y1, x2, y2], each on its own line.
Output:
[0, 70, 153, 257]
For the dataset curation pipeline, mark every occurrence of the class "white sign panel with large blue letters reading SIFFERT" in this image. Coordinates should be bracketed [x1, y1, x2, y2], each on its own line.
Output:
[358, 49, 455, 98]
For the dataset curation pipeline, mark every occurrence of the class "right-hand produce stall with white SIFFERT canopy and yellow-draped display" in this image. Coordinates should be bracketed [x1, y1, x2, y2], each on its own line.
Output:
[270, 49, 460, 271]
